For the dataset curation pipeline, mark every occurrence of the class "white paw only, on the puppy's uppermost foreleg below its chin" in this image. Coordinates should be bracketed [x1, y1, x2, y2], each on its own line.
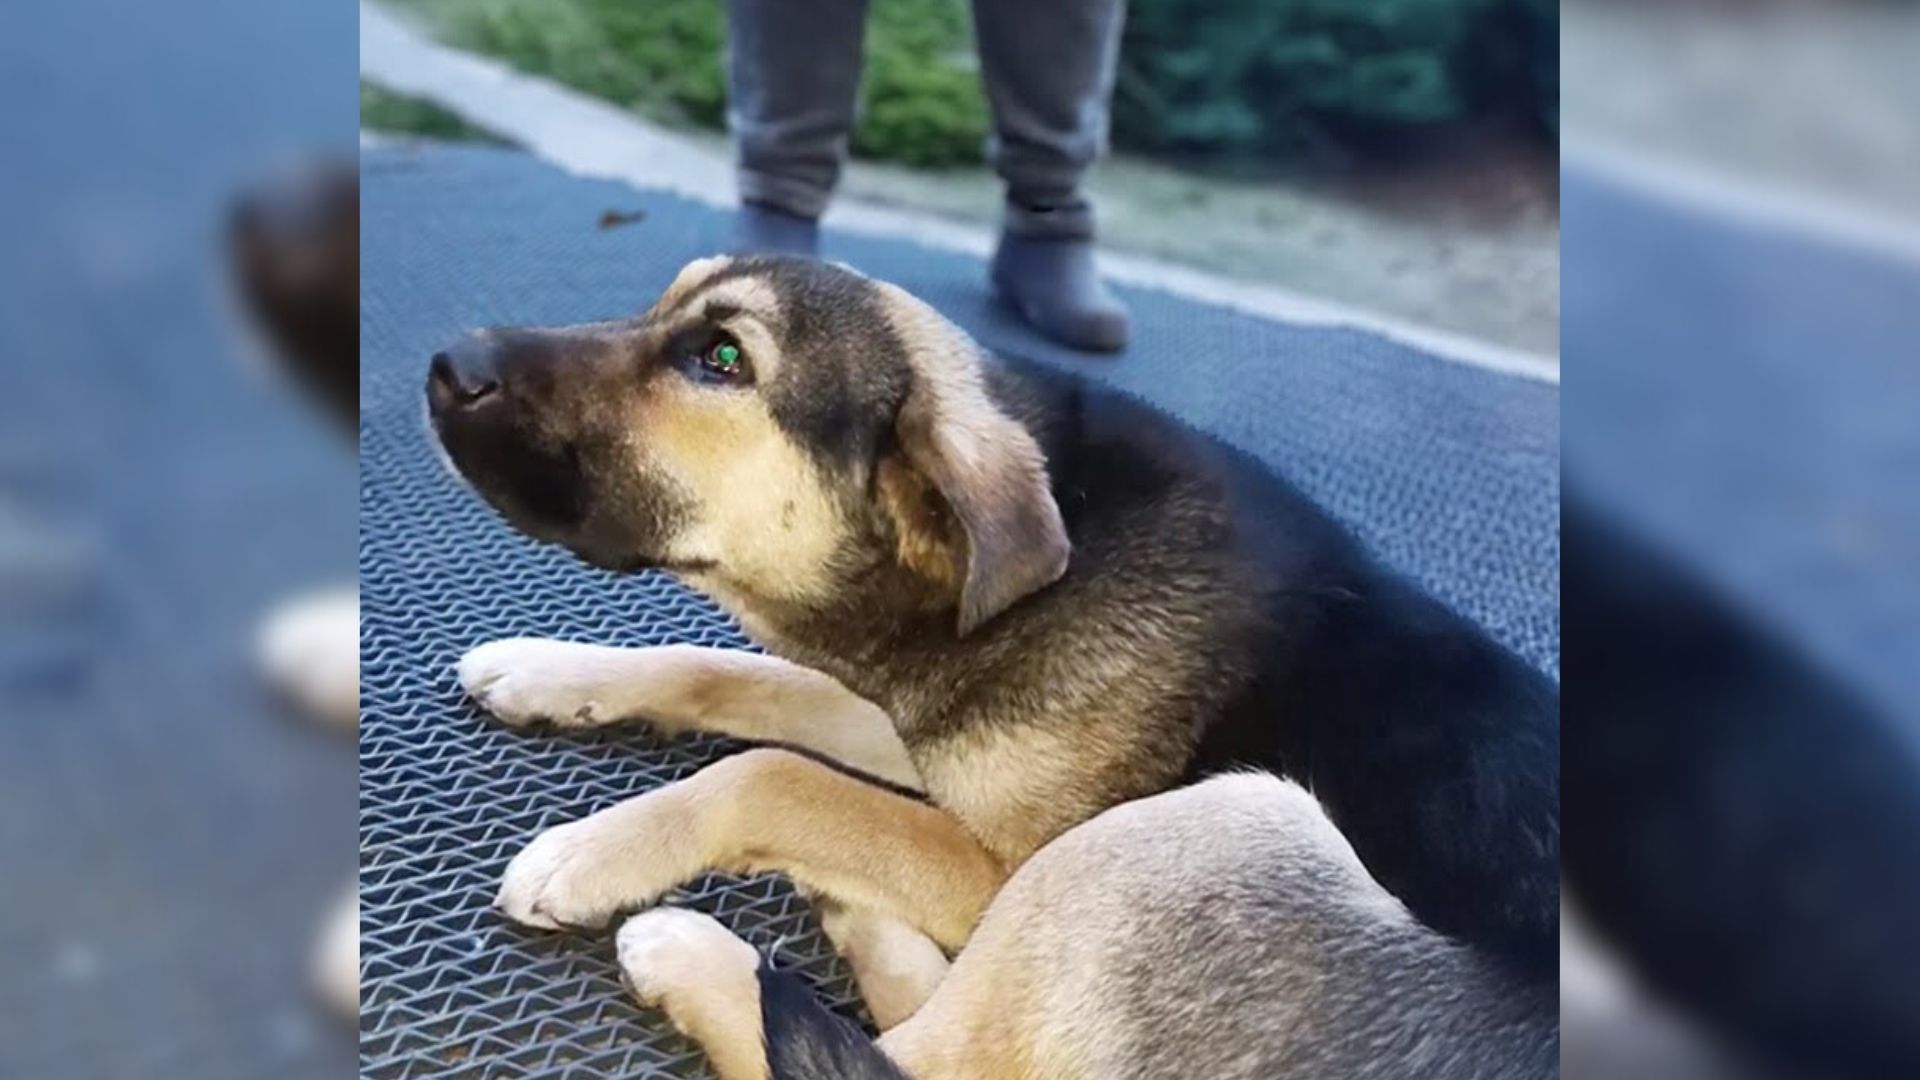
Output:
[459, 638, 622, 728]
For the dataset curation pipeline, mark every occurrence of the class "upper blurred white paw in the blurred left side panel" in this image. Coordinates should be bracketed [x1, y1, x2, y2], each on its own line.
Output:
[257, 590, 359, 728]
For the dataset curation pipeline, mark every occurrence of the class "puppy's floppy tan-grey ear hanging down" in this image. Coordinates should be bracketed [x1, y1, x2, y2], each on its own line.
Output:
[895, 345, 1071, 636]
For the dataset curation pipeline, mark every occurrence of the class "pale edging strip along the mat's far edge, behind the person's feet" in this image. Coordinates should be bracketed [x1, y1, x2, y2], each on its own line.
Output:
[359, 0, 1559, 384]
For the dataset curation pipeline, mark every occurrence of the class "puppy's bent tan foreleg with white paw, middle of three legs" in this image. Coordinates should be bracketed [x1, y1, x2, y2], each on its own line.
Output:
[497, 748, 1006, 949]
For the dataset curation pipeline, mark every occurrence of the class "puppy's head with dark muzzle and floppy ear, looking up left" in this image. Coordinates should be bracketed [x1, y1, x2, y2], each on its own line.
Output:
[426, 258, 1068, 634]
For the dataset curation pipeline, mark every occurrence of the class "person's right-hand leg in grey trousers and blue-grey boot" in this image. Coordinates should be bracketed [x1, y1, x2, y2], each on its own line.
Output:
[973, 0, 1127, 350]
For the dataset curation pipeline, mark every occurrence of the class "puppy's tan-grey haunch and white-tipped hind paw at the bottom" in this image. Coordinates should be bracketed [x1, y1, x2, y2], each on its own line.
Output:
[618, 774, 1559, 1080]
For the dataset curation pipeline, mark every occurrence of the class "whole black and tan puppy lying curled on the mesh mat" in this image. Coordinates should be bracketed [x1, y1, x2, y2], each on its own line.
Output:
[428, 259, 1559, 1080]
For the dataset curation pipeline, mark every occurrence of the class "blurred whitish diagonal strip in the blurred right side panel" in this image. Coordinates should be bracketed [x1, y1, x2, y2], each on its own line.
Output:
[1561, 133, 1920, 265]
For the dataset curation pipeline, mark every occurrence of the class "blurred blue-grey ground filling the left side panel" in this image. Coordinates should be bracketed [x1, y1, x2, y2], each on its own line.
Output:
[0, 0, 355, 1080]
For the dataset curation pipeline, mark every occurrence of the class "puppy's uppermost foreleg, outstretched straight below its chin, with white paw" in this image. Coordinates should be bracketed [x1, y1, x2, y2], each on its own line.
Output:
[459, 638, 922, 790]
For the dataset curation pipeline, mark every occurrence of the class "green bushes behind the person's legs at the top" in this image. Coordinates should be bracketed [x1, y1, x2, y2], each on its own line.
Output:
[388, 0, 1559, 165]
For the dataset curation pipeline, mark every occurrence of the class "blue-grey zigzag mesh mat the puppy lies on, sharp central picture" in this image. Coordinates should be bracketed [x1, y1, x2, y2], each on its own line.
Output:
[361, 148, 1559, 1080]
